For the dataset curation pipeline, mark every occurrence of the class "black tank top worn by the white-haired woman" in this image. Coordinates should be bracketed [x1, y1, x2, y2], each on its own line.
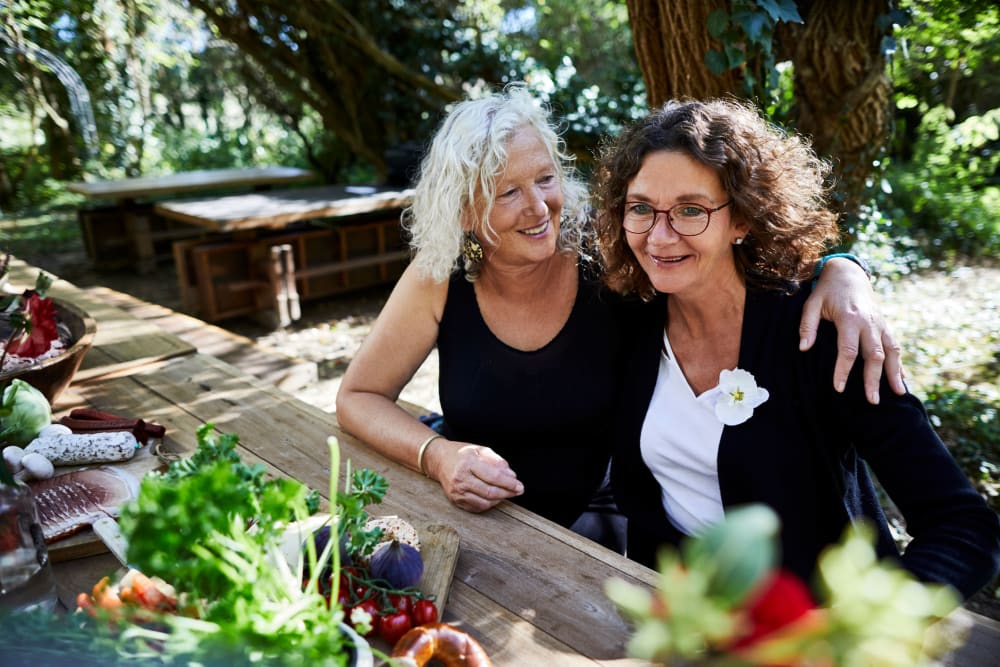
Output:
[437, 260, 620, 526]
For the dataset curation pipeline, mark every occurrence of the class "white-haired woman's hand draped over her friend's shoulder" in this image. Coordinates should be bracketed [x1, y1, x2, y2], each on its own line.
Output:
[799, 258, 906, 404]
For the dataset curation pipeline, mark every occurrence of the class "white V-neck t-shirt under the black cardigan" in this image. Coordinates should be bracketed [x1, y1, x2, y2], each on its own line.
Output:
[639, 332, 724, 535]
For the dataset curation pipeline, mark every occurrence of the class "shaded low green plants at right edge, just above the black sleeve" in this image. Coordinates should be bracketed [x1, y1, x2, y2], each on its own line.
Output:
[924, 386, 1000, 512]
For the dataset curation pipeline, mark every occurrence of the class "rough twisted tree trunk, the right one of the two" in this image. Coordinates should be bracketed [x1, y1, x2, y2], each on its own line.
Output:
[783, 0, 892, 211]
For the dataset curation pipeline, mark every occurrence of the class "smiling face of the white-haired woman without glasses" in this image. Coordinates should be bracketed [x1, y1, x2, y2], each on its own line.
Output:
[478, 127, 563, 266]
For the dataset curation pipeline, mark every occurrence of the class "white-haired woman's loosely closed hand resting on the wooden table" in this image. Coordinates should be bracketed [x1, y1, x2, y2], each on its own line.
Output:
[425, 439, 524, 512]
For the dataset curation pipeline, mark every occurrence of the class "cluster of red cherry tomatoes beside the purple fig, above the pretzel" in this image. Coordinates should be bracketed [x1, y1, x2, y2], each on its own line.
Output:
[312, 567, 438, 646]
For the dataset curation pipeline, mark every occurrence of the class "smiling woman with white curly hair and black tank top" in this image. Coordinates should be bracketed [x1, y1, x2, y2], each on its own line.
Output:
[337, 86, 901, 548]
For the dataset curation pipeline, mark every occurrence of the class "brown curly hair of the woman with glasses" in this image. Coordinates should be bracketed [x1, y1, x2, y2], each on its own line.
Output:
[592, 99, 838, 299]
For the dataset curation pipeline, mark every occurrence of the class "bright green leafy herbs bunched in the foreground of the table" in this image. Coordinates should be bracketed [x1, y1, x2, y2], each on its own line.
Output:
[110, 424, 388, 665]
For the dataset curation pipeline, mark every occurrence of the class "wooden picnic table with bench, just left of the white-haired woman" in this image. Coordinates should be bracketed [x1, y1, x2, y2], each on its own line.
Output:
[155, 185, 413, 326]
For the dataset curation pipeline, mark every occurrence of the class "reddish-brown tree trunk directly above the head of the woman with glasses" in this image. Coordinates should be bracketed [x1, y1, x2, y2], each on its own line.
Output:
[627, 0, 740, 109]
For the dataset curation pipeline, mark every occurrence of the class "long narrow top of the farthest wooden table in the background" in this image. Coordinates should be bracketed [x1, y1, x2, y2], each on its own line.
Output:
[66, 167, 316, 200]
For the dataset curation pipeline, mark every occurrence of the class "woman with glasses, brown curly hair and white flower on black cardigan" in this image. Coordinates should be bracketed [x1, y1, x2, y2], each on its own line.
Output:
[594, 100, 1000, 597]
